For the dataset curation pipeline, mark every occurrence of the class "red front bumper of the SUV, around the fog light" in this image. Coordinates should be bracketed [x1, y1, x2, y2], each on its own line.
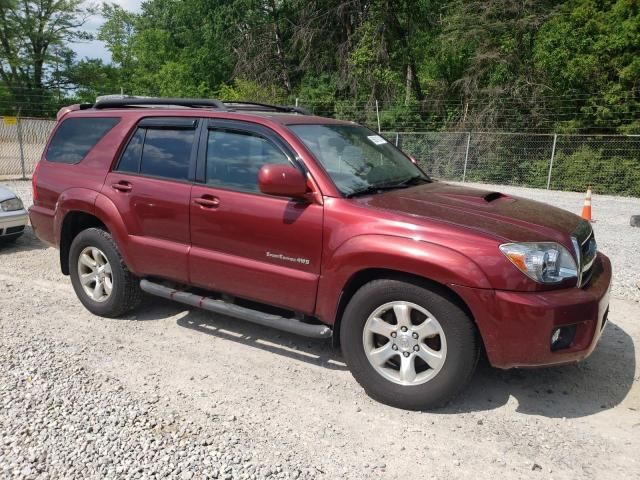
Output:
[453, 253, 611, 368]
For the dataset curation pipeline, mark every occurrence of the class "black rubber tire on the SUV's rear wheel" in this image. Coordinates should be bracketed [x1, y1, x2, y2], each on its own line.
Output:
[69, 228, 142, 318]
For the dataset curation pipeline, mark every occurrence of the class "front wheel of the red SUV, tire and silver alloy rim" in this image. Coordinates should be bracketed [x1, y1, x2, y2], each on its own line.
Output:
[340, 280, 480, 410]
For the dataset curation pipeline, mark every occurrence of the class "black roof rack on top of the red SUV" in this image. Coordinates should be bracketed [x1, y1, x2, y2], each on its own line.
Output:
[93, 95, 311, 115]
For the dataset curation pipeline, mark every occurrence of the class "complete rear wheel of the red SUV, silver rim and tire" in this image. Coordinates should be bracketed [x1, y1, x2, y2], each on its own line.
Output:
[69, 228, 142, 318]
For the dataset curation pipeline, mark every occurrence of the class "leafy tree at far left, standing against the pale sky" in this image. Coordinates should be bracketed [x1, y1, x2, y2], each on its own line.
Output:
[0, 0, 95, 115]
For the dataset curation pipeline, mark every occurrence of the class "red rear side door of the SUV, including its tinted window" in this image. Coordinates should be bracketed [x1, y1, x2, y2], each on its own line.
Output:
[102, 117, 199, 282]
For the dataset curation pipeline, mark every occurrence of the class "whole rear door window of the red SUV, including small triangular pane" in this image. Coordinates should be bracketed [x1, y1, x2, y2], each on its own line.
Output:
[116, 128, 195, 180]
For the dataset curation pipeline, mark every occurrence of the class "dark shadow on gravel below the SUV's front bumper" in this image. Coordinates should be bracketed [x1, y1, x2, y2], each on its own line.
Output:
[441, 322, 636, 418]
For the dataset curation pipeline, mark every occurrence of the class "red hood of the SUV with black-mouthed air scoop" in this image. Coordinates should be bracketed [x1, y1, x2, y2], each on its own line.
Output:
[357, 182, 581, 247]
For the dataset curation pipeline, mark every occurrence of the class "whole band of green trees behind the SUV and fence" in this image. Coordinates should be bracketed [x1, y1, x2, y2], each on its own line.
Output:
[0, 0, 640, 140]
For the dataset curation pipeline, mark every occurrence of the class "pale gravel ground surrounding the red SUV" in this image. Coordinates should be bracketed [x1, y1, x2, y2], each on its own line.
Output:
[0, 178, 640, 480]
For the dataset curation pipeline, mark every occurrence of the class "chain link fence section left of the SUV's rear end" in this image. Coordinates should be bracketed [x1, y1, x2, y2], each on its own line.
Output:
[0, 117, 55, 178]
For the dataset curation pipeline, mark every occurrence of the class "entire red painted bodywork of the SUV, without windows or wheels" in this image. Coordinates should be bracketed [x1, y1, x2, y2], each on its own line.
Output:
[30, 108, 611, 368]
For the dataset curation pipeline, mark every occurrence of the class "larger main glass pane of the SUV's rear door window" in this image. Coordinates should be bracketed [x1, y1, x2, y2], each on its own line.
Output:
[140, 128, 195, 180]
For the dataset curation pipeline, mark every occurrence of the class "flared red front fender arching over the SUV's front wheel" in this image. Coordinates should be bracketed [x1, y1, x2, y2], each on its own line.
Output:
[316, 235, 491, 324]
